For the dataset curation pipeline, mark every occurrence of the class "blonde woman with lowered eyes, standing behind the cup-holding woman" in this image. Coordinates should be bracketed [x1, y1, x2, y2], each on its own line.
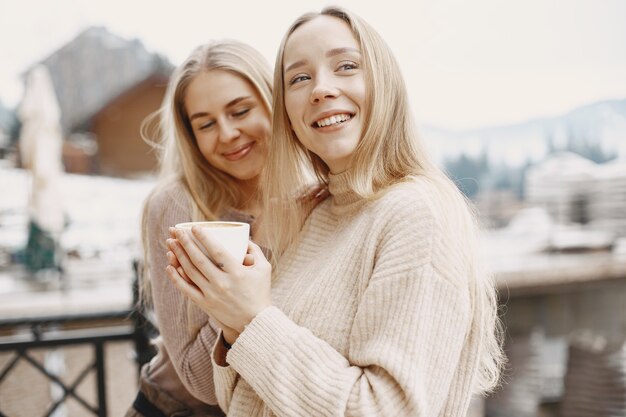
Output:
[126, 40, 272, 417]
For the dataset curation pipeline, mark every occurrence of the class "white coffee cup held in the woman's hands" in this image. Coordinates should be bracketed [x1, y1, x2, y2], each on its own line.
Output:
[174, 221, 250, 263]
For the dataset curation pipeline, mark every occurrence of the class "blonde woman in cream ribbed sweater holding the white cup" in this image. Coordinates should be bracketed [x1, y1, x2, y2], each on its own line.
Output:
[167, 7, 502, 417]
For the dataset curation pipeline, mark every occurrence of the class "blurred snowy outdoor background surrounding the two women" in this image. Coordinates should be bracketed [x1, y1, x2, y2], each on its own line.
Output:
[0, 0, 626, 417]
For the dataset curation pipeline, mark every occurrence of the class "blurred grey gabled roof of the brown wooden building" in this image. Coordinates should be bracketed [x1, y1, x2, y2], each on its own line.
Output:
[27, 27, 173, 133]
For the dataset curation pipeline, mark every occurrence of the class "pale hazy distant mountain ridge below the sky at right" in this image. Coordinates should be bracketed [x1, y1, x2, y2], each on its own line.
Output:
[422, 99, 626, 167]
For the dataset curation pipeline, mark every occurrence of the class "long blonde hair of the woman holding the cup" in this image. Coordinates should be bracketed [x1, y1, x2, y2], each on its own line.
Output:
[263, 7, 504, 392]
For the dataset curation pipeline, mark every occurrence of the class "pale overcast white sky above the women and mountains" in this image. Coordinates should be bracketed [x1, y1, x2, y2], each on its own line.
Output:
[0, 0, 626, 129]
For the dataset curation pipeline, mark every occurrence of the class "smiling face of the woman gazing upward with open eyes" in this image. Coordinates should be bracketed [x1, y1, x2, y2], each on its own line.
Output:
[283, 16, 366, 173]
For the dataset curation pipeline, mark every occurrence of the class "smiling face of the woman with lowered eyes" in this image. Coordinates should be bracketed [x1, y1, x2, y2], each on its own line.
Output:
[184, 70, 270, 181]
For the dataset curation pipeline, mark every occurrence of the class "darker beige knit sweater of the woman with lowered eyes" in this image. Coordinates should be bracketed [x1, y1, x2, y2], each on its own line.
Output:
[147, 182, 251, 411]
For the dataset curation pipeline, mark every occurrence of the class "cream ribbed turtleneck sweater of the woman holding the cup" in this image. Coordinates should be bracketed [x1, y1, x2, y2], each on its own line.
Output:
[212, 170, 482, 417]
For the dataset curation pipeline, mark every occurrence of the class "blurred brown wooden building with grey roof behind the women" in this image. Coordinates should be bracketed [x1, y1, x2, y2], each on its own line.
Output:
[23, 27, 173, 177]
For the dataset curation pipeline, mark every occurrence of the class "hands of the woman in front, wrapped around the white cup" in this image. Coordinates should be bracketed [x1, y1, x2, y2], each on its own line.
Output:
[167, 227, 272, 333]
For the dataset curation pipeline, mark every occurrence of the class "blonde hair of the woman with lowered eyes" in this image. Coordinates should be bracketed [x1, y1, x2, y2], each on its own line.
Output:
[140, 40, 272, 305]
